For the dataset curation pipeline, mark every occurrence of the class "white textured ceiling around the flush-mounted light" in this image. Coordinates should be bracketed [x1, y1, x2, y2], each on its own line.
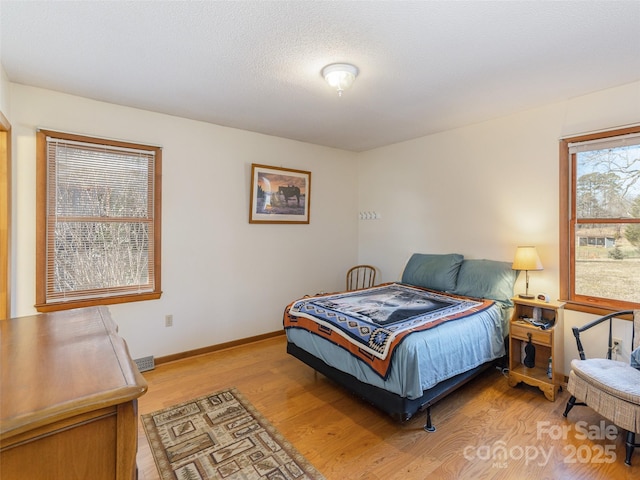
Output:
[0, 0, 640, 151]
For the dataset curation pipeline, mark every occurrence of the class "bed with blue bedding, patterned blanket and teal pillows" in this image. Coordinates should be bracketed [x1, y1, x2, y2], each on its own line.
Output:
[283, 253, 517, 431]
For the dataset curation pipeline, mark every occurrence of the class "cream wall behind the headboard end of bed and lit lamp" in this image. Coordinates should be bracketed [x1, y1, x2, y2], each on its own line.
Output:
[358, 82, 640, 373]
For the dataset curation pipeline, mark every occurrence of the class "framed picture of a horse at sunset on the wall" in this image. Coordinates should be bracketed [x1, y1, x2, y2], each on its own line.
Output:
[249, 163, 311, 223]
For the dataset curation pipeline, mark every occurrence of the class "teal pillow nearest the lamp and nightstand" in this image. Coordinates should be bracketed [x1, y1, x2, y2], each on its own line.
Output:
[451, 260, 518, 305]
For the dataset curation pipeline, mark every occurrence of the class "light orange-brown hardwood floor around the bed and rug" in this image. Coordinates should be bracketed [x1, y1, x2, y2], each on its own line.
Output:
[137, 336, 640, 480]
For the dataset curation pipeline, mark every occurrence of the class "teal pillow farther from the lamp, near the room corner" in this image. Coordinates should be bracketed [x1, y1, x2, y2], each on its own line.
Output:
[402, 253, 464, 292]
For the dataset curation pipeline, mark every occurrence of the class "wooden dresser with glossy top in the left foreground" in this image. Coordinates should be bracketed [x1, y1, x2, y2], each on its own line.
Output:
[0, 307, 147, 480]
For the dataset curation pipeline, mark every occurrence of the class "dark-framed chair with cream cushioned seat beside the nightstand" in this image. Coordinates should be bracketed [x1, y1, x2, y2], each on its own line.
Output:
[563, 310, 640, 465]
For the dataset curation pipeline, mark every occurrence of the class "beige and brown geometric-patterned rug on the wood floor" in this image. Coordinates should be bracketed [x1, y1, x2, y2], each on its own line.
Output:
[141, 388, 324, 480]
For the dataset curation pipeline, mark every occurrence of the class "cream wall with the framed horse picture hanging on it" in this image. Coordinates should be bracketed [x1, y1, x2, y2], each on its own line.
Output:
[11, 84, 358, 358]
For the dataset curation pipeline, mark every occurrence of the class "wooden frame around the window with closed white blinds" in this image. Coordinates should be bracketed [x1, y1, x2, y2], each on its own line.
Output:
[35, 129, 162, 312]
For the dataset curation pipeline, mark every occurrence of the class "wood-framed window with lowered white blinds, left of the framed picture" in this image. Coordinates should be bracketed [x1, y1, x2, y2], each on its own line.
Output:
[36, 130, 161, 311]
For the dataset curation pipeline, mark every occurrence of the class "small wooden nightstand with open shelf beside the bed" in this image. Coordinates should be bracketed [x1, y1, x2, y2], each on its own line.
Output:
[509, 297, 564, 402]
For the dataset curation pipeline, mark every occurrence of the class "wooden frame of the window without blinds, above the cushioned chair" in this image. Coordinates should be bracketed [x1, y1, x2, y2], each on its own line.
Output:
[559, 125, 640, 315]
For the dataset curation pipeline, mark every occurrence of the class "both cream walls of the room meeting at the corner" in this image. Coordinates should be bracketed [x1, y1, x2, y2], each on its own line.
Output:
[10, 78, 640, 373]
